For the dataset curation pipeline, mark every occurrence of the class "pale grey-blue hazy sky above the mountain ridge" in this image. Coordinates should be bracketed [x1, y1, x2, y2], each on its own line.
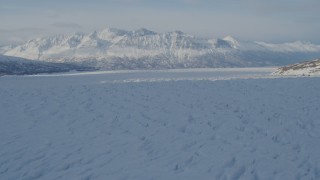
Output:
[0, 0, 320, 45]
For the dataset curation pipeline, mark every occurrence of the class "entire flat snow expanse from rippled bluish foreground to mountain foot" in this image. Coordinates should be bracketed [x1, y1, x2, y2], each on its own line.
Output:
[0, 68, 320, 180]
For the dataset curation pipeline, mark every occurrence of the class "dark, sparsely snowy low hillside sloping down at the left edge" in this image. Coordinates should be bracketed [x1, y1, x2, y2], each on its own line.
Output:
[0, 55, 94, 76]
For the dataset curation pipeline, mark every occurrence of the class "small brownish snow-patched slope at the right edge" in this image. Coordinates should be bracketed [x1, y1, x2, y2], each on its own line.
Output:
[273, 59, 320, 76]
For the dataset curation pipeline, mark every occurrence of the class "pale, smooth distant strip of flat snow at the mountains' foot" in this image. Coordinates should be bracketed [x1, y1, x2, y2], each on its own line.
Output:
[25, 67, 276, 83]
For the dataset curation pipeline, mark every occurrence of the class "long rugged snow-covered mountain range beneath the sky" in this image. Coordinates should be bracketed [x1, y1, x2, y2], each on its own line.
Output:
[2, 28, 320, 69]
